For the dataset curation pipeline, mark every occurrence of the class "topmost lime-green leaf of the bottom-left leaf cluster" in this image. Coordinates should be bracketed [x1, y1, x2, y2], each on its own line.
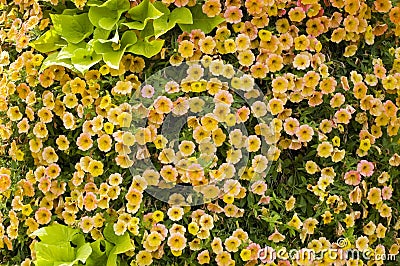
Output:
[32, 224, 79, 245]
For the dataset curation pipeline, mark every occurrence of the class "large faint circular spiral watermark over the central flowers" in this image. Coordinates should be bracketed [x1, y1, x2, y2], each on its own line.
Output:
[125, 60, 275, 205]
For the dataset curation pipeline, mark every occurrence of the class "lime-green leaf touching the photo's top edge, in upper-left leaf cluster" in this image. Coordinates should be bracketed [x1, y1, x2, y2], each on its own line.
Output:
[89, 0, 130, 30]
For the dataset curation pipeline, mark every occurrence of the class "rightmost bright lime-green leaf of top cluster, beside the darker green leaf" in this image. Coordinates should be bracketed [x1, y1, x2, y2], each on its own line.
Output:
[153, 2, 193, 38]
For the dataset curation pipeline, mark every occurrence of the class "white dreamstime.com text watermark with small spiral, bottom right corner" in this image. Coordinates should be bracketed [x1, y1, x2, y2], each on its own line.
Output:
[258, 238, 396, 263]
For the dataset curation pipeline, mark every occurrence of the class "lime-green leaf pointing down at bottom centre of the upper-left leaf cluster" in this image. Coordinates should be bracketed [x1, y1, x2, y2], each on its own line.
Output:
[93, 31, 137, 69]
